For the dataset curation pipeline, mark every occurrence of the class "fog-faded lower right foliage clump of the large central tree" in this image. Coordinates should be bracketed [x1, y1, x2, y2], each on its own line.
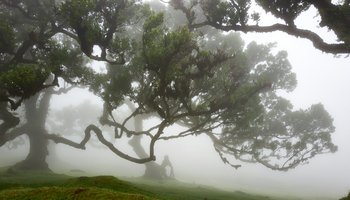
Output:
[221, 93, 337, 170]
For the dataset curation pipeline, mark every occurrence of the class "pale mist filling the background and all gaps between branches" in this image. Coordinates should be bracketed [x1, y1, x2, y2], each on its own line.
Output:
[0, 1, 350, 199]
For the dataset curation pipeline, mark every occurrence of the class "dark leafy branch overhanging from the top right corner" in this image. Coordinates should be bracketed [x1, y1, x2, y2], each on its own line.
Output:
[170, 0, 350, 54]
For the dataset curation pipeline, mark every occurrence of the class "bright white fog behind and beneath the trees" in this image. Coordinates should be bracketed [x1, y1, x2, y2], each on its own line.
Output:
[0, 1, 350, 199]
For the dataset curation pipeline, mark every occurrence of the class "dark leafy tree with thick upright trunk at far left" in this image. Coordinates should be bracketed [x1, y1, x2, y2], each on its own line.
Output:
[0, 0, 142, 170]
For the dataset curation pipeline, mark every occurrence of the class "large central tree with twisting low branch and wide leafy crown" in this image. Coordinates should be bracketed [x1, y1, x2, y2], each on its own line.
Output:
[50, 10, 336, 170]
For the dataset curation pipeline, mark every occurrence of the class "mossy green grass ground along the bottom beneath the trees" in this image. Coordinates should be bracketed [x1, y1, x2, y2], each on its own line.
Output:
[0, 168, 308, 200]
